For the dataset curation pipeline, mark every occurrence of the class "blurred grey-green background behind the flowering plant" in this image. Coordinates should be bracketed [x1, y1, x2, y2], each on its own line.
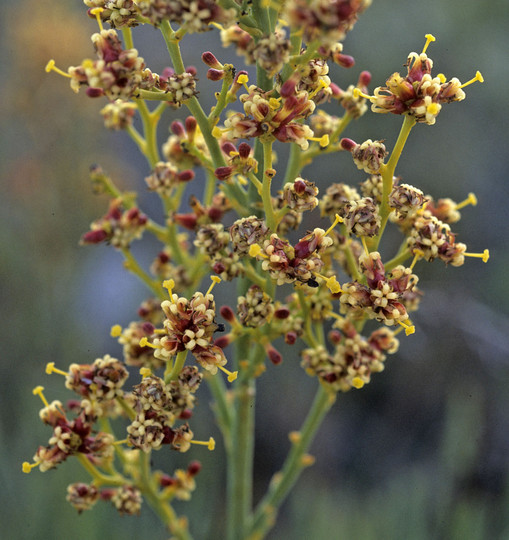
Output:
[0, 0, 509, 540]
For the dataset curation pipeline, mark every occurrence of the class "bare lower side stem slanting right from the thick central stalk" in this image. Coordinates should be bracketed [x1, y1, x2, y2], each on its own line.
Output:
[246, 386, 335, 539]
